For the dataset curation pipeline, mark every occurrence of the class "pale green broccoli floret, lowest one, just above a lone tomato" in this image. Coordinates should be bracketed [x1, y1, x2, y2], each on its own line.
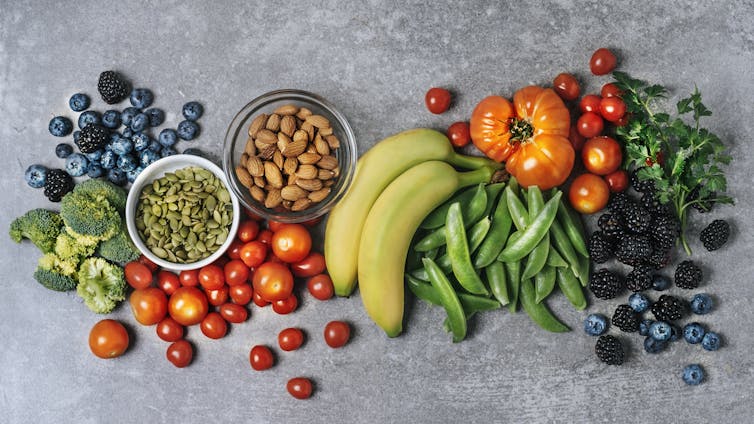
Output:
[76, 257, 126, 314]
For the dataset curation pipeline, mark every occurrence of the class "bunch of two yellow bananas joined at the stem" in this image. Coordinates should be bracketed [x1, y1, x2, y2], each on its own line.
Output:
[325, 128, 500, 337]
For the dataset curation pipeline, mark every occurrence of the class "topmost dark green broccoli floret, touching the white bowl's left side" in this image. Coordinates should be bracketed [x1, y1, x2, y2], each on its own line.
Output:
[60, 191, 121, 240]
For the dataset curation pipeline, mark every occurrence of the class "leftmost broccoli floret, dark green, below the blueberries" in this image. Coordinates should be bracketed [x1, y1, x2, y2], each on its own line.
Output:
[9, 209, 63, 253]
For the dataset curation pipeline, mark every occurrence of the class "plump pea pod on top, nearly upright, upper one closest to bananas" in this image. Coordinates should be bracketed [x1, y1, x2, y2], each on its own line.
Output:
[446, 203, 489, 296]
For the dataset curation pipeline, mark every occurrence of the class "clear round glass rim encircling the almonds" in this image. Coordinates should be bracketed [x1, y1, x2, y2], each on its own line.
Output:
[223, 89, 358, 223]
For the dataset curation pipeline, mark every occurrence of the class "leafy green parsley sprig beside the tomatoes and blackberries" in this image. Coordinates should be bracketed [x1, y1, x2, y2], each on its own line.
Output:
[613, 72, 733, 255]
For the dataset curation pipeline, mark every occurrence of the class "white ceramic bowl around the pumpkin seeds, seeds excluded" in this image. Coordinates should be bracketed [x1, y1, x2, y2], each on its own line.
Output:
[126, 155, 241, 271]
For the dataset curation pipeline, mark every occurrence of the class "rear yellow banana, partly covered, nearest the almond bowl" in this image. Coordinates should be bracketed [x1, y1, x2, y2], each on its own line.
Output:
[325, 128, 494, 296]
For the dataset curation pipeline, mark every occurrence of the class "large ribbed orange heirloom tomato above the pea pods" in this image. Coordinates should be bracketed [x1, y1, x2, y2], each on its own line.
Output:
[471, 86, 575, 190]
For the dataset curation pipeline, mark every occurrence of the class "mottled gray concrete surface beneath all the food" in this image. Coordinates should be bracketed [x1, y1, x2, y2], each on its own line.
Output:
[0, 0, 754, 423]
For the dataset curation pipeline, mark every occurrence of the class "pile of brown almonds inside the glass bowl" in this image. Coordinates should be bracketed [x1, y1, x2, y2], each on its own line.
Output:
[235, 104, 340, 212]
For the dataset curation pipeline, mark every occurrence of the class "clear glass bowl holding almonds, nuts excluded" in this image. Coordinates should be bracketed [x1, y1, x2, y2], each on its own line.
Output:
[223, 90, 358, 223]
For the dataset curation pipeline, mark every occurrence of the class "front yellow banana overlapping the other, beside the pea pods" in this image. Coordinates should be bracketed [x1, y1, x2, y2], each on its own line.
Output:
[358, 161, 494, 337]
